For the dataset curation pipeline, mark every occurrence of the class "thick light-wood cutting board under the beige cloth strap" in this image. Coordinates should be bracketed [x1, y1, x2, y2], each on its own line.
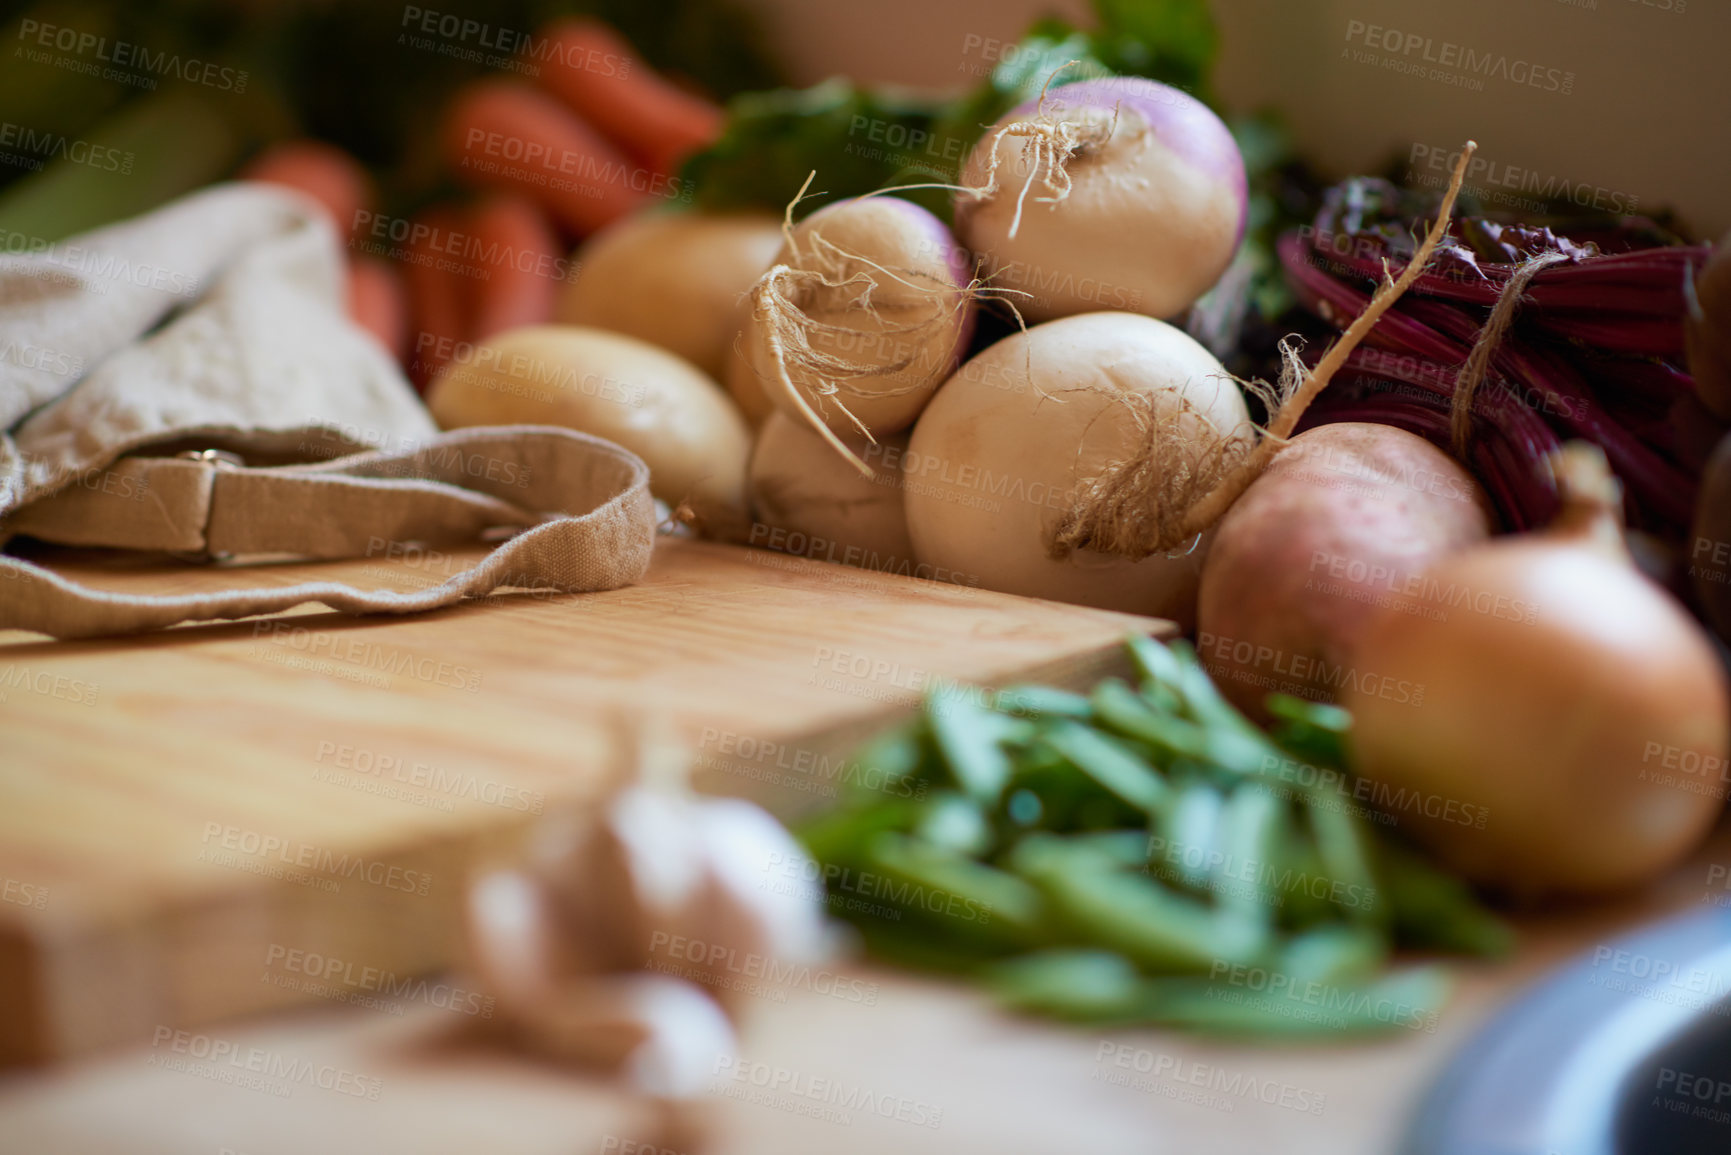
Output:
[0, 539, 1167, 1063]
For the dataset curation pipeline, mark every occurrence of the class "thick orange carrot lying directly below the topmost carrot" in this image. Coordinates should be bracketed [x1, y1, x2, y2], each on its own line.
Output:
[443, 80, 650, 234]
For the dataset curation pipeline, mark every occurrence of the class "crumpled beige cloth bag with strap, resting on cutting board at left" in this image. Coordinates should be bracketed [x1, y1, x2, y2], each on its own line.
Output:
[0, 185, 654, 637]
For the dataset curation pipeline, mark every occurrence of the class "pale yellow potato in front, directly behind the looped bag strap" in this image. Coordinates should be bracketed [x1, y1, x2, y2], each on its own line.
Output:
[428, 326, 751, 532]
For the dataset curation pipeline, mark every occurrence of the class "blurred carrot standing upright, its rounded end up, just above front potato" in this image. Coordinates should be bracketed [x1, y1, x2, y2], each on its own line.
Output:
[469, 192, 564, 341]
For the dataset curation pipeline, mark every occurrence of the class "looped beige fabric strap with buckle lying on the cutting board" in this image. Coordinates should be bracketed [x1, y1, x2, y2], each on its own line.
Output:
[0, 426, 654, 637]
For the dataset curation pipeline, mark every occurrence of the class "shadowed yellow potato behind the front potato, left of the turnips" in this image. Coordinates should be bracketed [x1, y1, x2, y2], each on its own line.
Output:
[554, 211, 782, 393]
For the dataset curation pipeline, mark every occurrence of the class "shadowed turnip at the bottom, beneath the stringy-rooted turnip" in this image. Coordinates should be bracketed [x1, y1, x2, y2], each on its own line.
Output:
[750, 412, 914, 571]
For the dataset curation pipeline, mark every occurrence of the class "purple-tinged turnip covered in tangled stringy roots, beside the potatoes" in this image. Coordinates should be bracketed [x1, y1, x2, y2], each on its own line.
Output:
[743, 196, 973, 471]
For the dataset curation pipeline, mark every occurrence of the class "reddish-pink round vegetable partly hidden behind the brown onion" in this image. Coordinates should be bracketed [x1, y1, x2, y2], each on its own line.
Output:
[1196, 423, 1490, 719]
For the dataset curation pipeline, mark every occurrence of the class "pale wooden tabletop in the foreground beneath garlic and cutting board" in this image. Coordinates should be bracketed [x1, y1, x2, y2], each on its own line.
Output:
[0, 831, 1731, 1155]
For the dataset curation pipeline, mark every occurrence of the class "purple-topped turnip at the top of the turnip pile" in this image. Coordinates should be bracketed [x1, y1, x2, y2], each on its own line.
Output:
[956, 76, 1248, 320]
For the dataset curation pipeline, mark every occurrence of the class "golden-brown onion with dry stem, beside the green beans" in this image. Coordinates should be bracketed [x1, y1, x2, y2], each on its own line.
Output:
[1342, 445, 1731, 895]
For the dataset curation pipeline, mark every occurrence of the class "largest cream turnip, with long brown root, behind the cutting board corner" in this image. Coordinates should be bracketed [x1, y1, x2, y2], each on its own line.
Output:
[904, 313, 1255, 622]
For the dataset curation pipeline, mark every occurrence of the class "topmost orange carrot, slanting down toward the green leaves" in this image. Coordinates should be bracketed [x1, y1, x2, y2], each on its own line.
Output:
[524, 19, 722, 175]
